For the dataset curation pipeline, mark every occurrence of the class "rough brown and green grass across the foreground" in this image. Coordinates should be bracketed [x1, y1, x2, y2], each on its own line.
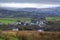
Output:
[0, 31, 60, 40]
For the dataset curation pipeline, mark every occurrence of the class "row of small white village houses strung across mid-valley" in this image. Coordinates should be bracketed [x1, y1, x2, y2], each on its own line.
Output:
[13, 21, 45, 27]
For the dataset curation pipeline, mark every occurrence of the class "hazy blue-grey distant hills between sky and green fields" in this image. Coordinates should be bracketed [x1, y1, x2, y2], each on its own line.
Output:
[0, 7, 60, 18]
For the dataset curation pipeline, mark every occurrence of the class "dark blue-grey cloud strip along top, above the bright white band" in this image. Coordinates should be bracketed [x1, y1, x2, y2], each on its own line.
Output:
[0, 0, 60, 4]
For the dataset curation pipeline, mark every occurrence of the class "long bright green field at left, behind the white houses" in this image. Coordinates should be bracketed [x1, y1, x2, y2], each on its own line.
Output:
[0, 18, 31, 24]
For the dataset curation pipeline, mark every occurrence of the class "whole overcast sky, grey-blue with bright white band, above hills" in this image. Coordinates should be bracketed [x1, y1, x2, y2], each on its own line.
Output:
[0, 0, 60, 8]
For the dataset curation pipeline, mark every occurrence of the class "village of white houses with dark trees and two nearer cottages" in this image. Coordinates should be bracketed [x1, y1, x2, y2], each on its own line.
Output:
[0, 18, 46, 31]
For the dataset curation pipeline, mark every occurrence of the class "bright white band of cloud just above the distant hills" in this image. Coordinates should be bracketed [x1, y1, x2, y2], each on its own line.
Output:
[0, 3, 60, 8]
